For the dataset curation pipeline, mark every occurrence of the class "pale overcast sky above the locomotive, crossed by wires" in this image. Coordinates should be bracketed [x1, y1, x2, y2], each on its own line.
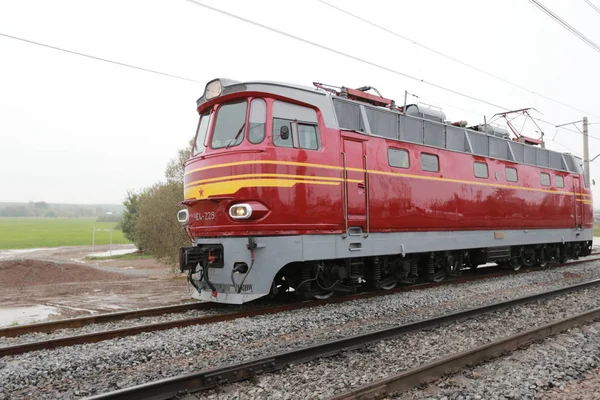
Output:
[0, 0, 600, 203]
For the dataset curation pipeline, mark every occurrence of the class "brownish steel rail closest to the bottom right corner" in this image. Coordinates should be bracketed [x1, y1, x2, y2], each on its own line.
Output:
[329, 308, 600, 400]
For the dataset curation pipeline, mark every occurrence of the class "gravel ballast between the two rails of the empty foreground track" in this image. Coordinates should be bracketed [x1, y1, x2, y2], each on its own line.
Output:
[198, 288, 600, 400]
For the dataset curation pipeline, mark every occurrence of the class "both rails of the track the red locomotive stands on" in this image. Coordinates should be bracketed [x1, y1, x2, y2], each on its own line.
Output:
[0, 253, 600, 357]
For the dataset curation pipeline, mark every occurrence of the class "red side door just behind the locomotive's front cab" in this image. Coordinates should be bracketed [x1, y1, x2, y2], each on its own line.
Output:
[342, 137, 368, 232]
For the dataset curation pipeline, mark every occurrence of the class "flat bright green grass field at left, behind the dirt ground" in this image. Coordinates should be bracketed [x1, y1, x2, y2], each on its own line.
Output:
[0, 218, 129, 249]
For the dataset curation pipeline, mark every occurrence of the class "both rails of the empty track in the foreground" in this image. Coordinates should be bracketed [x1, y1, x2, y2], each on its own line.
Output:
[85, 279, 600, 400]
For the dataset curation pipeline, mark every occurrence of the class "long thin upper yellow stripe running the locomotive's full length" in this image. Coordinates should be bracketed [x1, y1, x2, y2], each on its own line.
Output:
[185, 160, 592, 197]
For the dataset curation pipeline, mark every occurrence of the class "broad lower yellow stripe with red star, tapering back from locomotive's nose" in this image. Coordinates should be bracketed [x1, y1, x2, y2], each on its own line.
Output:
[185, 179, 340, 200]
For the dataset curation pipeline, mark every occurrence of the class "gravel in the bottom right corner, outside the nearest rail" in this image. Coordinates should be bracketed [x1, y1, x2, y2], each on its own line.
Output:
[393, 322, 600, 400]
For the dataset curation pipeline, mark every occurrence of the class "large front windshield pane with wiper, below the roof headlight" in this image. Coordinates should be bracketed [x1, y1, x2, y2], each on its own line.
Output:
[210, 100, 248, 149]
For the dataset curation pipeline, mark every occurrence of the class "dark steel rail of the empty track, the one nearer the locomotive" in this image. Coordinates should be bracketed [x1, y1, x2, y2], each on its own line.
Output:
[89, 279, 600, 400]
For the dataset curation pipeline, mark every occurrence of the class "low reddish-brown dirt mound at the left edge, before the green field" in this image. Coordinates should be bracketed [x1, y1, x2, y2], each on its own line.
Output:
[0, 260, 131, 287]
